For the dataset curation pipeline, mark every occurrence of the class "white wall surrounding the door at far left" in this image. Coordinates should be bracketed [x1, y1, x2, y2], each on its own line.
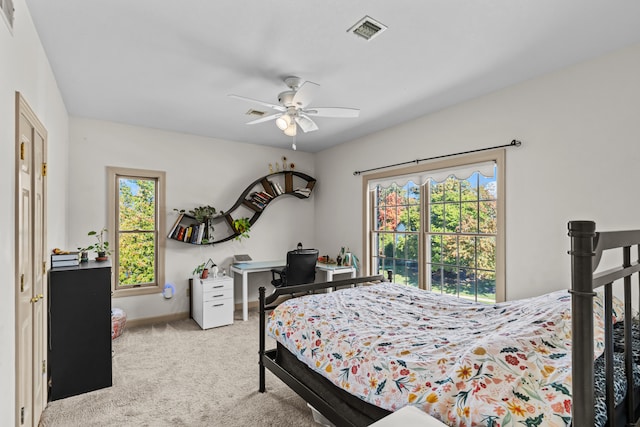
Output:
[0, 0, 68, 425]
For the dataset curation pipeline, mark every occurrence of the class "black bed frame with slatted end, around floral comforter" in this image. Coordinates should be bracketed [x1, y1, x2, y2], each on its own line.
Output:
[259, 221, 640, 427]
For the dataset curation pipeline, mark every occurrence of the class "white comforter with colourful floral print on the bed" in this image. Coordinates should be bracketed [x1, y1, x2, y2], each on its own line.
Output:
[267, 283, 619, 427]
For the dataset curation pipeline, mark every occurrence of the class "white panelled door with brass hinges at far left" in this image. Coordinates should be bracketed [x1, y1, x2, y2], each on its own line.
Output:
[15, 93, 47, 427]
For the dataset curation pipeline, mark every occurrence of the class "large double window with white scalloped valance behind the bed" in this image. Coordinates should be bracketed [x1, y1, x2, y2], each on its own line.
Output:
[364, 150, 505, 303]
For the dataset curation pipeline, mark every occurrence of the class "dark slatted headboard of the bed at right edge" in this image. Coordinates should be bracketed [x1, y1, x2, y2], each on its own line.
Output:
[568, 221, 640, 426]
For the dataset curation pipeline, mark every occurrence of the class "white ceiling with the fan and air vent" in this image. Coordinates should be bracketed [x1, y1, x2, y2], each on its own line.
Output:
[22, 0, 640, 152]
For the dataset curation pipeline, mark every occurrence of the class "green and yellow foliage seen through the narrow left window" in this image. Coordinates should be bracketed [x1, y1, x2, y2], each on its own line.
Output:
[118, 178, 157, 287]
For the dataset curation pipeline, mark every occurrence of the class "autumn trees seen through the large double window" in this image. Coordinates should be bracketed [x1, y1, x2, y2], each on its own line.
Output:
[374, 173, 497, 302]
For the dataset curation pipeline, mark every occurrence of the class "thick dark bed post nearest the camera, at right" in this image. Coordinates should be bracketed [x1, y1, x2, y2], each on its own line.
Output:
[568, 221, 596, 427]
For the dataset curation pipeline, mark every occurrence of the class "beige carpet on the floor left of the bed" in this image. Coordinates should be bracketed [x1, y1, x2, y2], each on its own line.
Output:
[40, 313, 319, 427]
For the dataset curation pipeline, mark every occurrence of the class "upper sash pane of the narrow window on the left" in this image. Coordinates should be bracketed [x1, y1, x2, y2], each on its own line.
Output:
[118, 178, 156, 230]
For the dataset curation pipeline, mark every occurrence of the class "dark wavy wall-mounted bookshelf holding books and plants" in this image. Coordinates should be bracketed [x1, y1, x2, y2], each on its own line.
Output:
[167, 170, 316, 245]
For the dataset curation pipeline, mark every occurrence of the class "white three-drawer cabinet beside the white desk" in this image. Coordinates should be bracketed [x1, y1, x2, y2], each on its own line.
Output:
[192, 276, 234, 329]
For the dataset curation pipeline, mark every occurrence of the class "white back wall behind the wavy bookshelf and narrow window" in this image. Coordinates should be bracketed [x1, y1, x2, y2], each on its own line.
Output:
[68, 118, 322, 319]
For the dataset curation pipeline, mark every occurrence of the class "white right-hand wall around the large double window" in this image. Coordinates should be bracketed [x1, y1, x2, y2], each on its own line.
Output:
[316, 45, 640, 299]
